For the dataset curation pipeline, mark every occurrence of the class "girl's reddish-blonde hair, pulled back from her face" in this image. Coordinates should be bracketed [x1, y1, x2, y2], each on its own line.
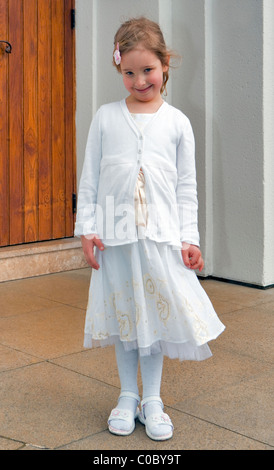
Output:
[113, 16, 175, 93]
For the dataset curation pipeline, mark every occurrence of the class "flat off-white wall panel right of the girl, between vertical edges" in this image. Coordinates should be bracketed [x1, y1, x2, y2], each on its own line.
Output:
[212, 0, 264, 284]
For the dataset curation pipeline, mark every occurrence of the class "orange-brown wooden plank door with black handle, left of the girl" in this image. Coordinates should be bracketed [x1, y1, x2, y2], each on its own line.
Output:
[0, 0, 76, 246]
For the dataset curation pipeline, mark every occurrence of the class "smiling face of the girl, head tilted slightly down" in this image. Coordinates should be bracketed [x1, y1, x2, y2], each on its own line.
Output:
[121, 47, 168, 102]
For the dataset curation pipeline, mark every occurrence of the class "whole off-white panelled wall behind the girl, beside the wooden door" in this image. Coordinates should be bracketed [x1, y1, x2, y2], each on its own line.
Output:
[76, 0, 274, 286]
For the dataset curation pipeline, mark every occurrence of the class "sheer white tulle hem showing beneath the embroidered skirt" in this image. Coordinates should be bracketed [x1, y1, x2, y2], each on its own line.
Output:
[84, 333, 212, 361]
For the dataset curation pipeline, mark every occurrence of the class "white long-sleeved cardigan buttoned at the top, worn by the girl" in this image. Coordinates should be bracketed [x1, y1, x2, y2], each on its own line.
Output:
[75, 100, 199, 247]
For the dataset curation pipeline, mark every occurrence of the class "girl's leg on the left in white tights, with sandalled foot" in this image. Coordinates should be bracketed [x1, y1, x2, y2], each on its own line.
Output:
[109, 340, 139, 432]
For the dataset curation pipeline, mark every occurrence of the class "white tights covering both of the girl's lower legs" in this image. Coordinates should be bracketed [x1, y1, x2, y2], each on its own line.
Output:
[108, 341, 163, 430]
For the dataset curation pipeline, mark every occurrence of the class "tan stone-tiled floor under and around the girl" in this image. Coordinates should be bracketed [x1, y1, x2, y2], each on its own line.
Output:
[0, 269, 274, 450]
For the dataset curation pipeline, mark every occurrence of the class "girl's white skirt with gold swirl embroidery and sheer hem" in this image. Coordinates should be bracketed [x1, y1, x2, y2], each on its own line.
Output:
[84, 239, 225, 361]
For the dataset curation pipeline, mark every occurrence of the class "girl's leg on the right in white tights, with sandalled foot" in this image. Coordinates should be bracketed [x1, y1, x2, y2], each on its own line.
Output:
[140, 353, 173, 440]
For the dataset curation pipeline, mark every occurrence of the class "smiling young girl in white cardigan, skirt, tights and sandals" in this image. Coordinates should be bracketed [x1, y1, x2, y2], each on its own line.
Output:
[75, 18, 224, 440]
